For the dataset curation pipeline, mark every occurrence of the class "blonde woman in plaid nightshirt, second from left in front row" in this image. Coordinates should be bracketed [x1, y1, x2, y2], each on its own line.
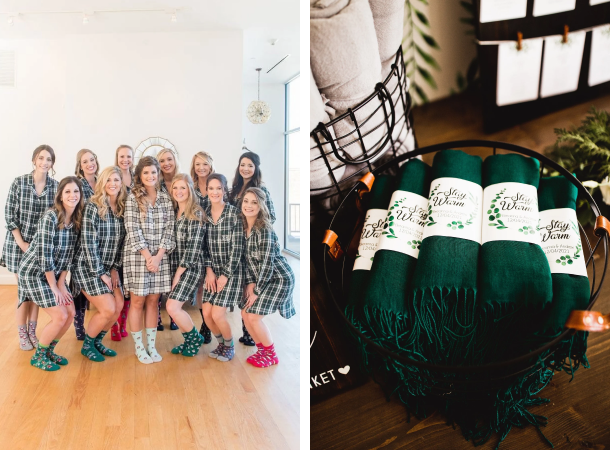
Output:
[72, 166, 127, 361]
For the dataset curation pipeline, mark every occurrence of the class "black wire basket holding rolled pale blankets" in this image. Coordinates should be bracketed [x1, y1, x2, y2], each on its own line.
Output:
[309, 46, 417, 222]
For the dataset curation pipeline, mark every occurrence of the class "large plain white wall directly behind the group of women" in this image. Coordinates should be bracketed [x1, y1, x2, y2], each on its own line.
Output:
[0, 30, 242, 283]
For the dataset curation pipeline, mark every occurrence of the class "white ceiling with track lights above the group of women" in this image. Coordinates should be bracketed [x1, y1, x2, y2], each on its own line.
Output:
[0, 0, 300, 84]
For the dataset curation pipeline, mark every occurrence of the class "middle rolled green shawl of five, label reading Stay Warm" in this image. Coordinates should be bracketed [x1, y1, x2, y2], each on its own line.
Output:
[412, 150, 482, 364]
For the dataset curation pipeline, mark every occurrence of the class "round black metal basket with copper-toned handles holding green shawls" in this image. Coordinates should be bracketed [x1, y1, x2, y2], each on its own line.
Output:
[323, 140, 608, 396]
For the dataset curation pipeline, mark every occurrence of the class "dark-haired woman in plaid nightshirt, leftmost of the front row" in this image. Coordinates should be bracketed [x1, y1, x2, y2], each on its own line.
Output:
[18, 176, 83, 371]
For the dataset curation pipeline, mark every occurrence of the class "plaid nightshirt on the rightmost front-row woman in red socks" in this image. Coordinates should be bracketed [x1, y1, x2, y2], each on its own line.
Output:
[240, 228, 296, 319]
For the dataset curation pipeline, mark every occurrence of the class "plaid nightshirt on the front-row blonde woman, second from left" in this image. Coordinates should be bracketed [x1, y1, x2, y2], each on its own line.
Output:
[72, 202, 125, 296]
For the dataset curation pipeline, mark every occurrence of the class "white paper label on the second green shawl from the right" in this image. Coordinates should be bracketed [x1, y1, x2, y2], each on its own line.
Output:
[483, 183, 540, 245]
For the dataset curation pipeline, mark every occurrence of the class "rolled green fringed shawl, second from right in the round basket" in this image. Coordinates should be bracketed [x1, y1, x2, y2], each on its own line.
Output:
[479, 153, 553, 360]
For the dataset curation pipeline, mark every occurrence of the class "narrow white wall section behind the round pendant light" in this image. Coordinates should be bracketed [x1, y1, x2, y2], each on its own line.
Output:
[240, 84, 286, 248]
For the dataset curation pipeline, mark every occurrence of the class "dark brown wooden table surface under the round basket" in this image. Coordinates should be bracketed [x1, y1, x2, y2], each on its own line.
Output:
[310, 94, 610, 450]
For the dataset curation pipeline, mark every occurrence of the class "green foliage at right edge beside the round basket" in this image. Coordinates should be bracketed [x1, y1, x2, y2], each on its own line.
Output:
[544, 106, 610, 226]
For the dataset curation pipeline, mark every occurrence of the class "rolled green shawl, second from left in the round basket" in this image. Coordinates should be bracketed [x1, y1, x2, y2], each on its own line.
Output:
[363, 159, 430, 343]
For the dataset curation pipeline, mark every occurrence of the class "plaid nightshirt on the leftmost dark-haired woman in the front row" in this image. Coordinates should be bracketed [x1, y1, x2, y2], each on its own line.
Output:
[18, 209, 77, 308]
